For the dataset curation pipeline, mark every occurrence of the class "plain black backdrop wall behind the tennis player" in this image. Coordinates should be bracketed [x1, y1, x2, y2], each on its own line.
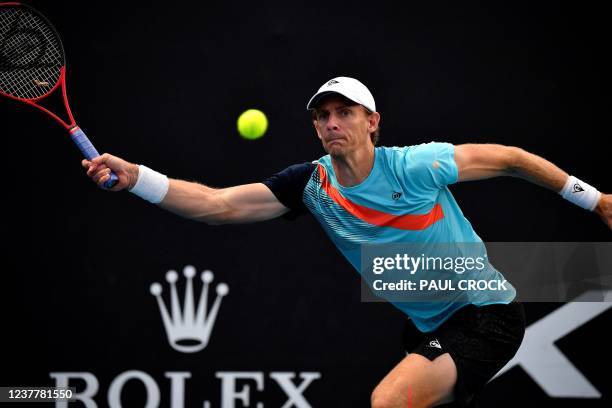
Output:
[0, 1, 612, 407]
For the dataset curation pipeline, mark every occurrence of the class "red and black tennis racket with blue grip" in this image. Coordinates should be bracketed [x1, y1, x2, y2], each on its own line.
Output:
[0, 3, 119, 188]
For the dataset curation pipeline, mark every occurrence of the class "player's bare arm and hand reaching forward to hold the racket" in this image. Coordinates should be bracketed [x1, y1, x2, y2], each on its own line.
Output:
[82, 153, 289, 224]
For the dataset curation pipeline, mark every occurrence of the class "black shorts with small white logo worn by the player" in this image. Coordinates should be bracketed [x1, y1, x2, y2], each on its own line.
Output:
[402, 301, 525, 407]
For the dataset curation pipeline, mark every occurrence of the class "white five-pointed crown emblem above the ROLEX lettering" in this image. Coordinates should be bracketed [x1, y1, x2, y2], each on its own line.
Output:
[151, 266, 229, 353]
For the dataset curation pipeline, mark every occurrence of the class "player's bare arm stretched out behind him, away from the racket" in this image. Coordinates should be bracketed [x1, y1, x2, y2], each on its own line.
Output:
[455, 144, 612, 229]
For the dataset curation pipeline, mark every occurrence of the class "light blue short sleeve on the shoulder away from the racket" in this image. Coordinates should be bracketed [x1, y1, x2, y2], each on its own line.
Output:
[405, 142, 459, 189]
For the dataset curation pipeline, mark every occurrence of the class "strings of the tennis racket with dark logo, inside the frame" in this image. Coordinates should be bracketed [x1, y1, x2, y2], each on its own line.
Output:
[0, 7, 64, 99]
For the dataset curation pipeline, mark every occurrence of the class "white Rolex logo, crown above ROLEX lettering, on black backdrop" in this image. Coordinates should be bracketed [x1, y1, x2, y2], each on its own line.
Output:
[49, 266, 321, 408]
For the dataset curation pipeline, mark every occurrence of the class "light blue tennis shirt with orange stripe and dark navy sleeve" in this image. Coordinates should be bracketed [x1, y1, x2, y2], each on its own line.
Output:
[263, 142, 516, 332]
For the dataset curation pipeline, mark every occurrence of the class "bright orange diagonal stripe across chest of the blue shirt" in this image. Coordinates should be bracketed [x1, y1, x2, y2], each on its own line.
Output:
[318, 164, 444, 231]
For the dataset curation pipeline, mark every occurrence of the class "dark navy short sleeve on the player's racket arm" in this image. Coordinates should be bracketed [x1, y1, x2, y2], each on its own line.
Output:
[262, 162, 316, 220]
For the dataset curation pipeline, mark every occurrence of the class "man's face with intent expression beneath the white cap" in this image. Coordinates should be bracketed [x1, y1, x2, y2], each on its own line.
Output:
[314, 95, 379, 157]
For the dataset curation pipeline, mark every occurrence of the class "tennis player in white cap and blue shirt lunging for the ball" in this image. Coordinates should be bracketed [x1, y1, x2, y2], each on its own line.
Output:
[83, 77, 612, 408]
